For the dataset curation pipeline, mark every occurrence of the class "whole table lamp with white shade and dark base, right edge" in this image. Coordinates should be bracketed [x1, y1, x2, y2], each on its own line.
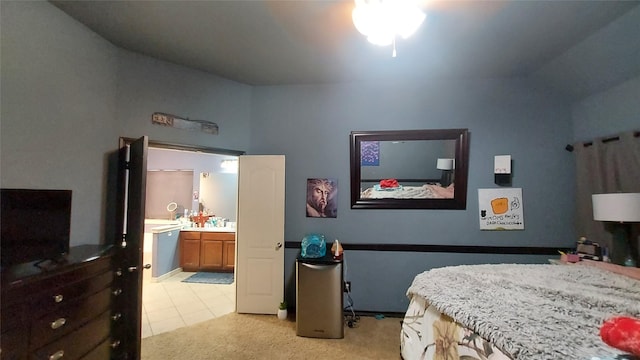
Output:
[591, 193, 640, 266]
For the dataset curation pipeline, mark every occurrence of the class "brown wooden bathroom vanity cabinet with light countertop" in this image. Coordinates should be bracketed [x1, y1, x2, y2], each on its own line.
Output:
[180, 227, 236, 272]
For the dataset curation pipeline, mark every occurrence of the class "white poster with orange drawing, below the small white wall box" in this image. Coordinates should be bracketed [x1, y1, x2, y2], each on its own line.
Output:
[478, 188, 524, 230]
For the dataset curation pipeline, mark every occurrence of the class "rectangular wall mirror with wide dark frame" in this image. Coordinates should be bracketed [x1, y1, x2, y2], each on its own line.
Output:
[350, 129, 469, 210]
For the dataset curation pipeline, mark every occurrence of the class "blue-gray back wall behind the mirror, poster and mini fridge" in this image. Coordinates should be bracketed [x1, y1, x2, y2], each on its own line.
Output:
[251, 80, 575, 312]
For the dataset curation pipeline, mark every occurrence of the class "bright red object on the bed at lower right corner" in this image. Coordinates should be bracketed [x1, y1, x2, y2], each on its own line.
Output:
[600, 316, 640, 356]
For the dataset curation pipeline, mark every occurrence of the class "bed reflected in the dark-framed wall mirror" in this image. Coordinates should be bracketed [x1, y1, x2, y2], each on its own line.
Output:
[360, 184, 454, 199]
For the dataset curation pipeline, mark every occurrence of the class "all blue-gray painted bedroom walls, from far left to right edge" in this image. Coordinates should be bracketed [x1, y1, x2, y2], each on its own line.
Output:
[0, 1, 640, 312]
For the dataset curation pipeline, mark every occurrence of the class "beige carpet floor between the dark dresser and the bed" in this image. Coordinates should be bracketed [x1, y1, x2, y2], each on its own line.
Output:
[141, 313, 401, 360]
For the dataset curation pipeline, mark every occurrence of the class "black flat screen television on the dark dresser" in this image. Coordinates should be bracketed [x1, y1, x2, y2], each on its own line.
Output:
[0, 189, 71, 268]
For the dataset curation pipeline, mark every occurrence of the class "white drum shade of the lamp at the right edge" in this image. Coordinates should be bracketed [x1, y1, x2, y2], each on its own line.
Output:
[591, 193, 640, 222]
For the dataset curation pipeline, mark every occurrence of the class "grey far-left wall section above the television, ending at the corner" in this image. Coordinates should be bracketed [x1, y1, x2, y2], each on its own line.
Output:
[0, 1, 119, 246]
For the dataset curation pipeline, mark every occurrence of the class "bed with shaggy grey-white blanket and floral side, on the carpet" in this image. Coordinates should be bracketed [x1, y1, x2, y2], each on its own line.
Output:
[400, 262, 640, 360]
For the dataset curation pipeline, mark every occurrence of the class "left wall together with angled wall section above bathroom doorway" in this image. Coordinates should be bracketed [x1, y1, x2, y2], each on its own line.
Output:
[0, 1, 251, 250]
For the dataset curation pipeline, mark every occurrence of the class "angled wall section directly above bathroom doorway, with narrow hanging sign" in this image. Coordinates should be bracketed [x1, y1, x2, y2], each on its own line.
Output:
[116, 50, 251, 151]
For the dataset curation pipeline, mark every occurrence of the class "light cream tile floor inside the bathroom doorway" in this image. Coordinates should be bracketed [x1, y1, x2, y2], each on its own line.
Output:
[142, 272, 236, 338]
